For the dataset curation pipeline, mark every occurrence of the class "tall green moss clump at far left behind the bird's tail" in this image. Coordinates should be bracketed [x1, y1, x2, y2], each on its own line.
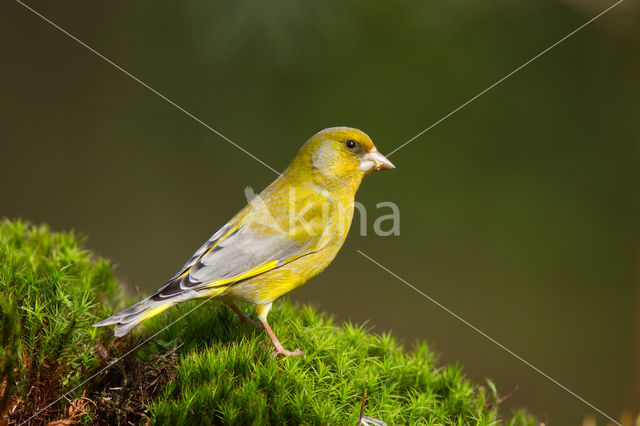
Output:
[0, 220, 121, 416]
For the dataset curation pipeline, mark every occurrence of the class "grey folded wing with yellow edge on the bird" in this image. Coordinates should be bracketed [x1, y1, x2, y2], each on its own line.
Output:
[152, 223, 322, 300]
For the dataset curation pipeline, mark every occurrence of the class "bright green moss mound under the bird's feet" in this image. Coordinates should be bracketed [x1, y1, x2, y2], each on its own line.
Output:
[144, 301, 532, 425]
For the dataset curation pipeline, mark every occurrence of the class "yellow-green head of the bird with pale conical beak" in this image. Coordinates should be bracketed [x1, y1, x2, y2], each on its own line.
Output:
[289, 127, 395, 191]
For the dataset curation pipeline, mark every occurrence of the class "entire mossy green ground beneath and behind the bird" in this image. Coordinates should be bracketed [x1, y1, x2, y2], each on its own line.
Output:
[0, 221, 534, 425]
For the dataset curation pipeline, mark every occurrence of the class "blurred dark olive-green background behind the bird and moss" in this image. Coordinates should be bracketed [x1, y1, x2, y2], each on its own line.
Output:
[0, 0, 640, 425]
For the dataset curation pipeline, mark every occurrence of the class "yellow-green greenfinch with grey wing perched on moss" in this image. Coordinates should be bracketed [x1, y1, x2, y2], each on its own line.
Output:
[94, 127, 394, 356]
